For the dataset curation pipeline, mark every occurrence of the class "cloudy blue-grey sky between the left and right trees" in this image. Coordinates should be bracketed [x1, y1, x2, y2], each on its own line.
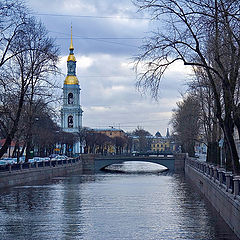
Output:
[26, 0, 187, 135]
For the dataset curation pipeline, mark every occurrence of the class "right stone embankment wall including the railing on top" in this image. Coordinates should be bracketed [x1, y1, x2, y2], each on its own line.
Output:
[185, 158, 240, 238]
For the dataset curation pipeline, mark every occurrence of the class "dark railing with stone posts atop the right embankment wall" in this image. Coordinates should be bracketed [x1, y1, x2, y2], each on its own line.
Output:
[186, 158, 240, 200]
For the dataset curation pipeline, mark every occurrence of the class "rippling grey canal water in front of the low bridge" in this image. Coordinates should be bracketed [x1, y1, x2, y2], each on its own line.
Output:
[0, 161, 237, 240]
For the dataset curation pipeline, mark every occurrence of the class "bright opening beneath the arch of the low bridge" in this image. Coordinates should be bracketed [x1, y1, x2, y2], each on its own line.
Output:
[101, 161, 168, 173]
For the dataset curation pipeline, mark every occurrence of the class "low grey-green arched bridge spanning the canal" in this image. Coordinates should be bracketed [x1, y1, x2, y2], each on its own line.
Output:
[94, 155, 184, 172]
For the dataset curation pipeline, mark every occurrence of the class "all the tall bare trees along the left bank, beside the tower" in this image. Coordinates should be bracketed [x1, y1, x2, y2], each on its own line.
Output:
[0, 0, 59, 159]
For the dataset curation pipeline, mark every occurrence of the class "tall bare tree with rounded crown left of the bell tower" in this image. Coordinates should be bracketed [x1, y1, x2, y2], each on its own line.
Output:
[0, 14, 58, 157]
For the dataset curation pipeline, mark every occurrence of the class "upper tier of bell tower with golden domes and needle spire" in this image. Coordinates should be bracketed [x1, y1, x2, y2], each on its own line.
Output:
[64, 27, 79, 85]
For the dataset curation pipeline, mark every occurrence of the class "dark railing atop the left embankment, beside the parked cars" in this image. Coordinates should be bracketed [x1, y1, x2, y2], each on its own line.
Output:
[0, 156, 81, 174]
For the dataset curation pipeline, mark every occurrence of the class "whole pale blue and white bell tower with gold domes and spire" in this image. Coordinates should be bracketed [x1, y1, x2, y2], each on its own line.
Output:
[61, 27, 83, 154]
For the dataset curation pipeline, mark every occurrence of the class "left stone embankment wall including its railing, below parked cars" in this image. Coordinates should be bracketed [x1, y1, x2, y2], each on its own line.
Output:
[0, 158, 82, 188]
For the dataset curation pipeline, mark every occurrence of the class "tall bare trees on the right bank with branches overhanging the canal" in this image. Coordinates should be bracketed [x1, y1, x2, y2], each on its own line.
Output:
[135, 0, 240, 174]
